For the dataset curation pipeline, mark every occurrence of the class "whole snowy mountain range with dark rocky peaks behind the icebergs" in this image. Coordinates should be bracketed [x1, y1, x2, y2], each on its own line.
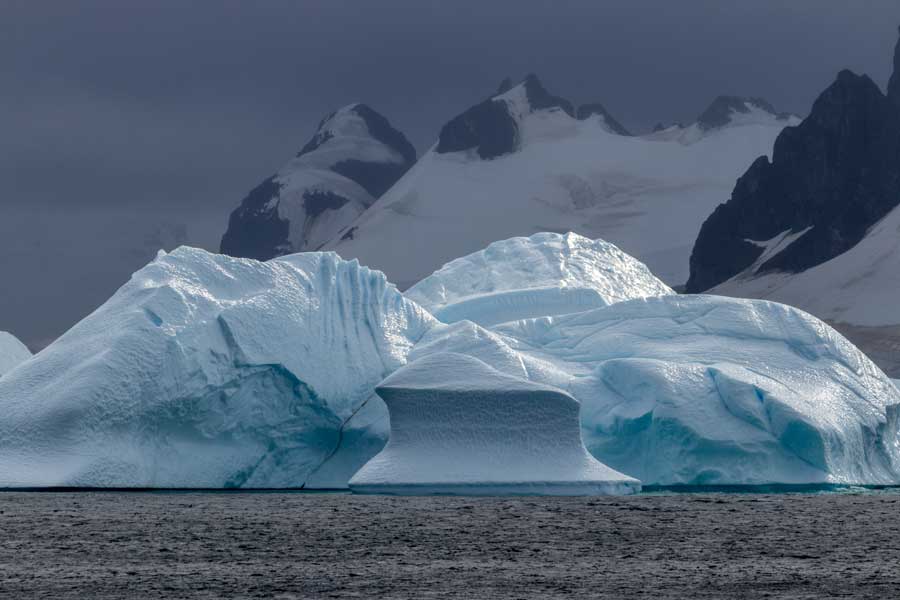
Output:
[222, 30, 900, 376]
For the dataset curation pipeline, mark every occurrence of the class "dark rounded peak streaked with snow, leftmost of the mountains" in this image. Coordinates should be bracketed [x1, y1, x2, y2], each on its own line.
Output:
[222, 104, 416, 260]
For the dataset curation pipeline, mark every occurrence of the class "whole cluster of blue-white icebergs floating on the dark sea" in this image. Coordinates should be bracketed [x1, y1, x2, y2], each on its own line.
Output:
[7, 234, 900, 493]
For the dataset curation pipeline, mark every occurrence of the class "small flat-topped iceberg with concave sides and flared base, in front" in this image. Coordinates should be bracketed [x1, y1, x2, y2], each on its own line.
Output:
[350, 353, 640, 495]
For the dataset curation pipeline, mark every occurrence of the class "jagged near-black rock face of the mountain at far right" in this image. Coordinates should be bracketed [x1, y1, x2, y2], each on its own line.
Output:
[687, 71, 900, 292]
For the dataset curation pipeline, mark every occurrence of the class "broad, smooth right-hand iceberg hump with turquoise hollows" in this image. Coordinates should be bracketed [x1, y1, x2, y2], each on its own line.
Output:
[410, 296, 900, 485]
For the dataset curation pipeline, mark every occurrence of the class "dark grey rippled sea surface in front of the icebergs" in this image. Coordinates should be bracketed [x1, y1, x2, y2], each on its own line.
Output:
[0, 486, 900, 599]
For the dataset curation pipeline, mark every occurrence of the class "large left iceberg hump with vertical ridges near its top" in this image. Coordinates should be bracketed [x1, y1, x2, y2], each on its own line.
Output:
[0, 247, 434, 487]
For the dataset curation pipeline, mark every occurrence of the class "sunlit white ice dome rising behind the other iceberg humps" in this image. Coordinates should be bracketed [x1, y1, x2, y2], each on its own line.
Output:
[405, 233, 674, 326]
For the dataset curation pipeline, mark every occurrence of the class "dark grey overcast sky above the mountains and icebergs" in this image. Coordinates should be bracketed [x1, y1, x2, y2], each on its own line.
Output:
[0, 0, 900, 348]
